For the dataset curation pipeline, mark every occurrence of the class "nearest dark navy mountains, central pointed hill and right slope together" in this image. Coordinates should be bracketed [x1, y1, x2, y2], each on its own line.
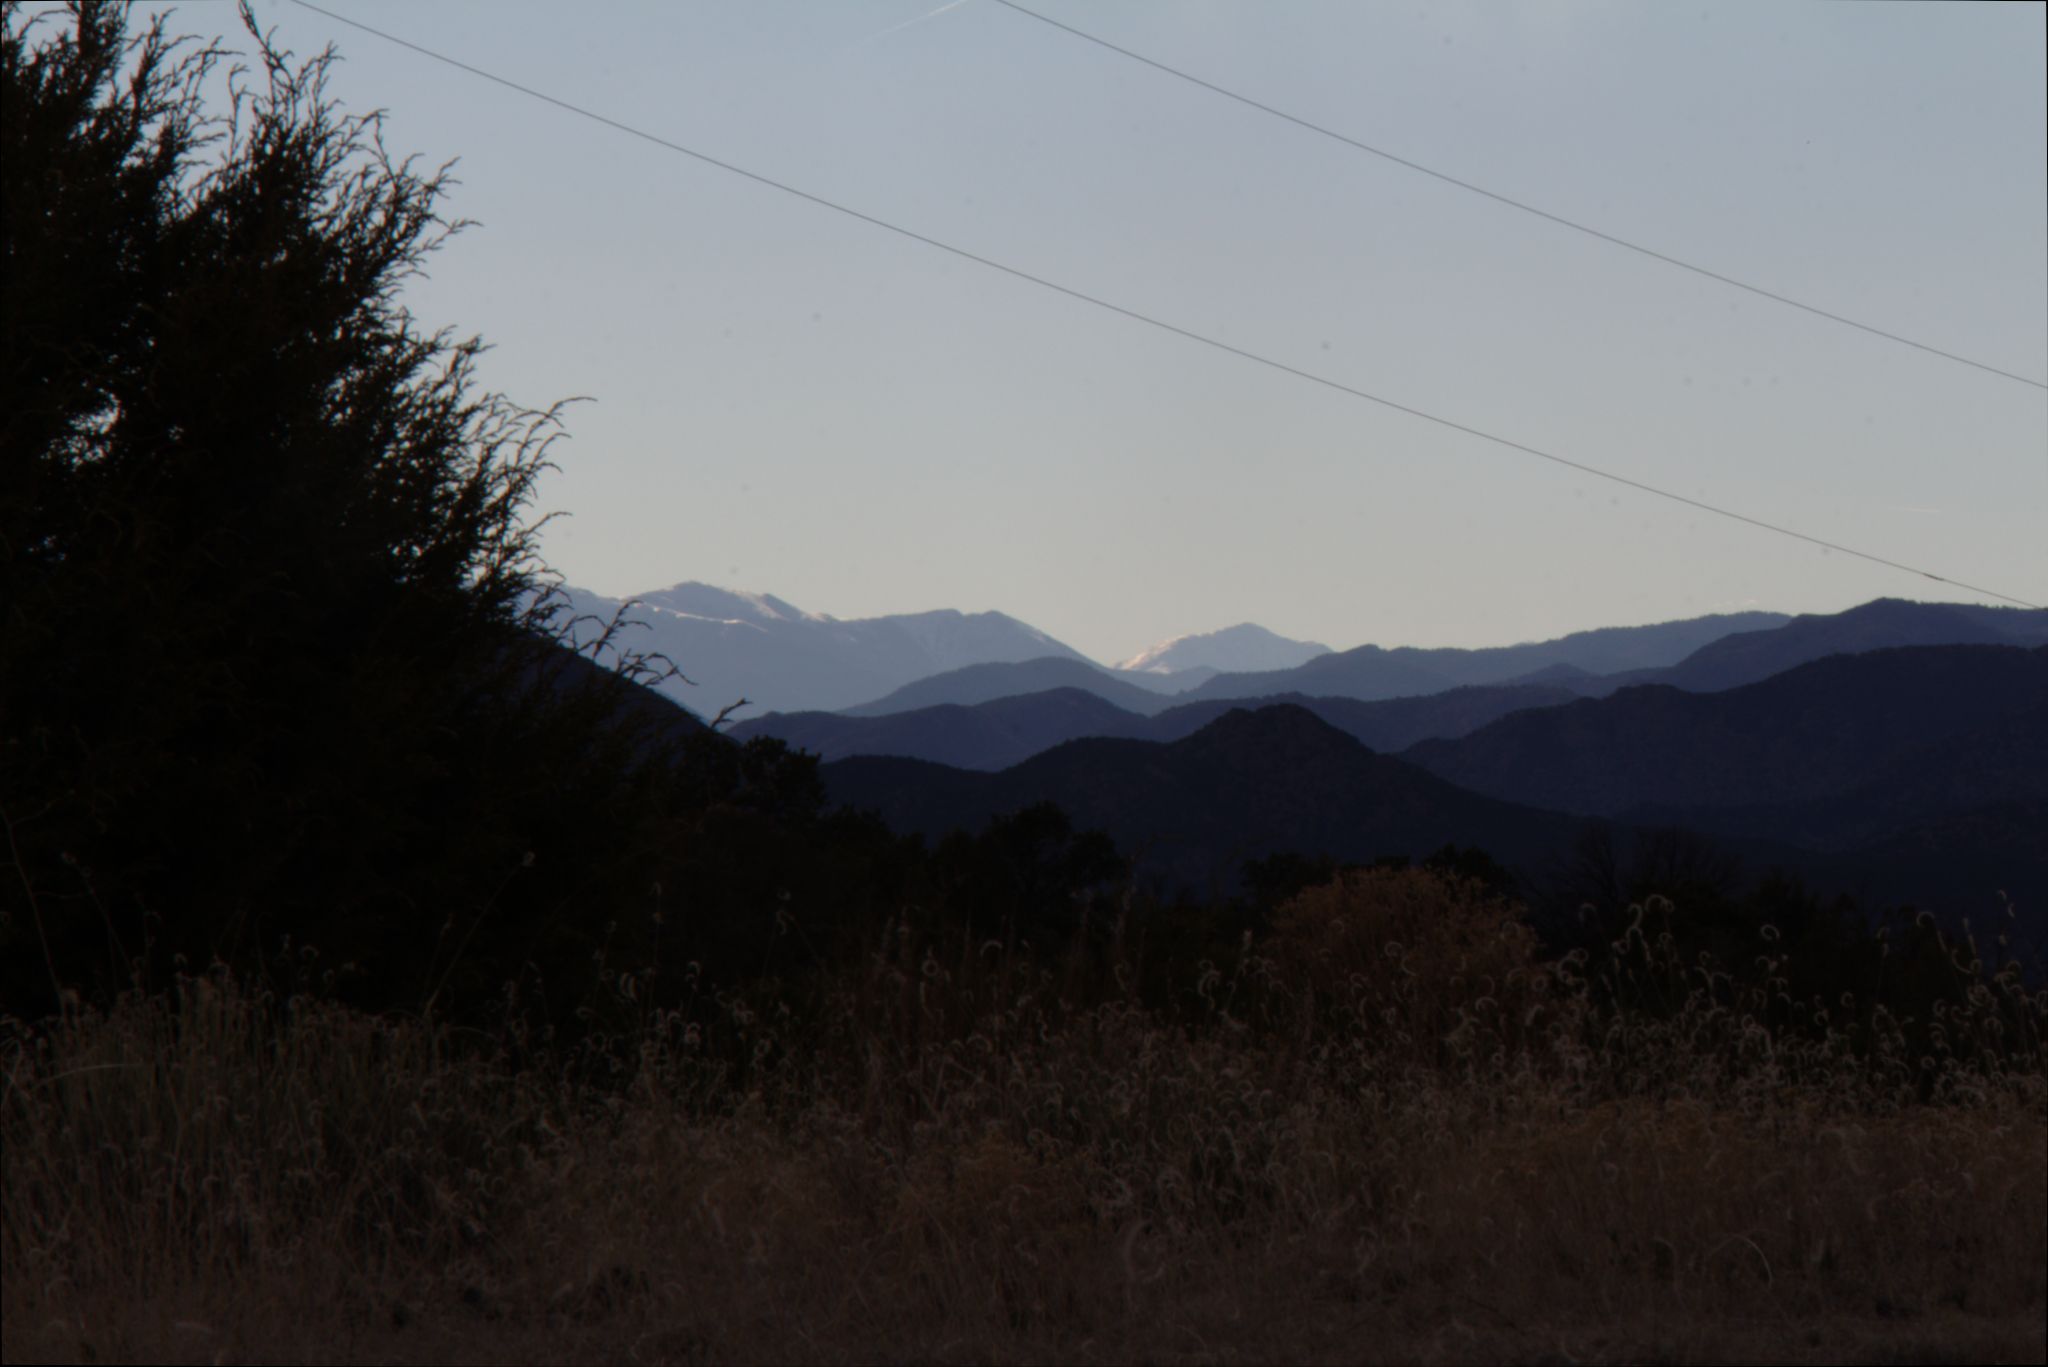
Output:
[821, 646, 2048, 937]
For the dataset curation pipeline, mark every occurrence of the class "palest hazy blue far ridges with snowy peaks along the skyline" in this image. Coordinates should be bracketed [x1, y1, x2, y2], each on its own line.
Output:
[567, 582, 2048, 748]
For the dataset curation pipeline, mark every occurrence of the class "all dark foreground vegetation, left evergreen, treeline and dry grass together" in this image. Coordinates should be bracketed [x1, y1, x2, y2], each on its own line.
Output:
[0, 4, 2048, 1363]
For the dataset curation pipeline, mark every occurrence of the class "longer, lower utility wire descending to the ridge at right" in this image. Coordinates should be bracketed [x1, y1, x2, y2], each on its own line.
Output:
[276, 0, 2040, 609]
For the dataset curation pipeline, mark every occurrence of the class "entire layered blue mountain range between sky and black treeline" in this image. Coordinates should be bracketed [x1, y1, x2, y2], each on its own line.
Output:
[552, 584, 2048, 950]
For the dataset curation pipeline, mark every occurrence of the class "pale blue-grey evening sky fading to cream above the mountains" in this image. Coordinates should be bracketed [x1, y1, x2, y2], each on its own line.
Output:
[128, 0, 2048, 660]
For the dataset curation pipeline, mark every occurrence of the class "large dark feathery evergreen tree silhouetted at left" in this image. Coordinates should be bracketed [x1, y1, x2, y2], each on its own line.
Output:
[0, 2, 724, 1010]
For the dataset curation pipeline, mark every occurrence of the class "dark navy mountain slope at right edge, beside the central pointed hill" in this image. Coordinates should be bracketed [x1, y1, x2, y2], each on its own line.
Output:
[1403, 646, 2048, 844]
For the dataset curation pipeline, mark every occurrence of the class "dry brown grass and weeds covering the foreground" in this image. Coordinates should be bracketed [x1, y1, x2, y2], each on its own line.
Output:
[0, 871, 2048, 1363]
